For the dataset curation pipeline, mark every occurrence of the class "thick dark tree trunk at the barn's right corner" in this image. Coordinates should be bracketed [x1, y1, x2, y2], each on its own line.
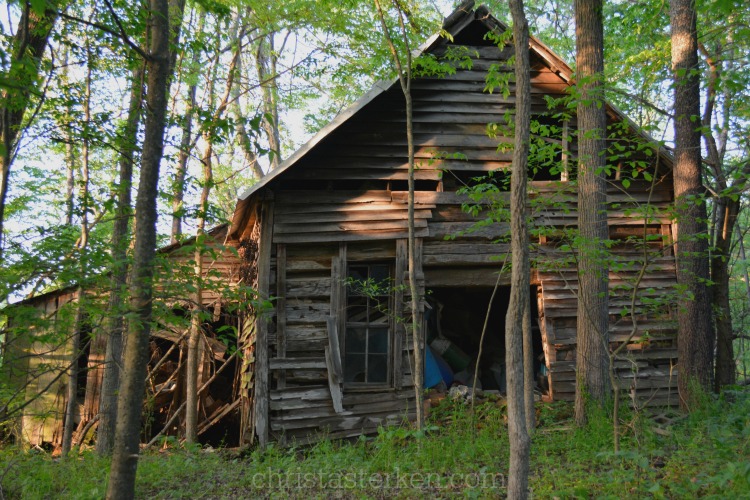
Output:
[669, 0, 714, 404]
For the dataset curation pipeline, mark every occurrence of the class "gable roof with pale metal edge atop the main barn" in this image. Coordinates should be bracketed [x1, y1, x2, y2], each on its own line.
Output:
[230, 0, 671, 234]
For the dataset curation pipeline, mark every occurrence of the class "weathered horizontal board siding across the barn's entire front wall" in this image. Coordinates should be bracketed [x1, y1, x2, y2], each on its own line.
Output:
[253, 22, 675, 441]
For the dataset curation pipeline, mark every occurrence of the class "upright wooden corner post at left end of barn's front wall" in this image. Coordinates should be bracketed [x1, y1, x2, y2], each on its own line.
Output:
[253, 201, 273, 448]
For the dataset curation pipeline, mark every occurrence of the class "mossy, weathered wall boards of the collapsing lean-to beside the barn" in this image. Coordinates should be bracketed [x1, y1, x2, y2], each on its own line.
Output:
[2, 225, 247, 446]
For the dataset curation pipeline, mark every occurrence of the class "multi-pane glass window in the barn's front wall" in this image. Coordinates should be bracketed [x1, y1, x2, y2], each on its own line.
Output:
[344, 264, 391, 385]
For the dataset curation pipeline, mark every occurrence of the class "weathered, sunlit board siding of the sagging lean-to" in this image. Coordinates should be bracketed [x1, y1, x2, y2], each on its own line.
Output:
[4, 226, 241, 445]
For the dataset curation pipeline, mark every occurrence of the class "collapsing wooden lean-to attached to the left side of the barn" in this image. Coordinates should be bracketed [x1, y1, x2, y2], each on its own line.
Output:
[2, 224, 241, 448]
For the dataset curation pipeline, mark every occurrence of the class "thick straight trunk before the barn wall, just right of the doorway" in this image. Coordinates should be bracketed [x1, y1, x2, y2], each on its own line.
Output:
[575, 0, 610, 425]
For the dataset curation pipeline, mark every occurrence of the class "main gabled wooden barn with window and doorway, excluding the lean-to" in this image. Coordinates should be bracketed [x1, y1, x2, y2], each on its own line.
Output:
[1, 2, 677, 450]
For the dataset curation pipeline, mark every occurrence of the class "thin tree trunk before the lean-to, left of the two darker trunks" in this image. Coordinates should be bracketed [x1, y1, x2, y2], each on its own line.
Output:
[62, 47, 93, 458]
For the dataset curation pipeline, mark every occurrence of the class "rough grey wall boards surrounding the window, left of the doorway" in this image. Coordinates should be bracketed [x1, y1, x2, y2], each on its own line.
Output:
[269, 240, 424, 442]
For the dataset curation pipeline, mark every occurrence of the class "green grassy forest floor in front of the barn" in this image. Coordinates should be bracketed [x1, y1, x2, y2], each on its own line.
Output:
[0, 388, 750, 499]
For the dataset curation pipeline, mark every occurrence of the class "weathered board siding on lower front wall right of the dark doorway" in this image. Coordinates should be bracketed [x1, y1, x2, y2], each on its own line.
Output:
[537, 182, 678, 405]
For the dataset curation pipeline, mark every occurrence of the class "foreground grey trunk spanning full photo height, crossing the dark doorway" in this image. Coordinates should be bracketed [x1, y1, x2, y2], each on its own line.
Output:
[505, 0, 534, 499]
